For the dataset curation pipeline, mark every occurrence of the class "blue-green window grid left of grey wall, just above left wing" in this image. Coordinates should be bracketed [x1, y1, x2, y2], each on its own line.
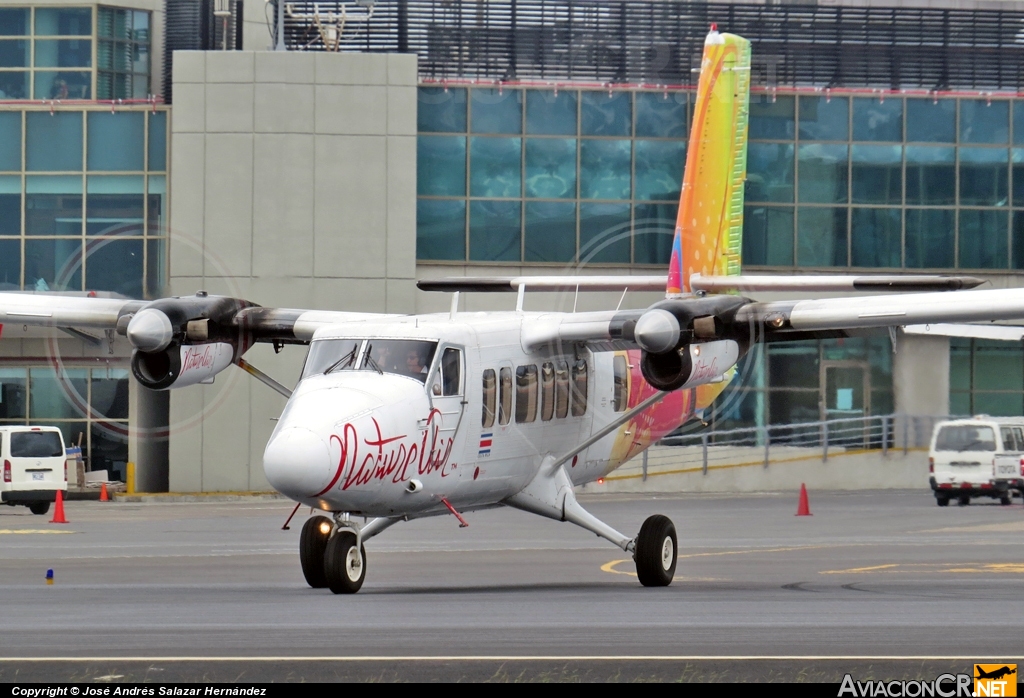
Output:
[0, 107, 168, 298]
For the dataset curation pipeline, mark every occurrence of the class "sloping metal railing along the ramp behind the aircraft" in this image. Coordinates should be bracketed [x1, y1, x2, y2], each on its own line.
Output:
[641, 415, 949, 480]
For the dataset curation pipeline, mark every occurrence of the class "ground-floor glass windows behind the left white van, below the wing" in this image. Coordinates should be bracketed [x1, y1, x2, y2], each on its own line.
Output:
[0, 364, 129, 480]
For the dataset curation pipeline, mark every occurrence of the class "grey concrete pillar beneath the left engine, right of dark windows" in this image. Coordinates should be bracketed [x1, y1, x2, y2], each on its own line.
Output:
[128, 378, 170, 492]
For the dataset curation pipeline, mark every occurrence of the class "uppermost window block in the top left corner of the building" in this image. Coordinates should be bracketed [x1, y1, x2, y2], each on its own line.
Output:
[0, 5, 152, 100]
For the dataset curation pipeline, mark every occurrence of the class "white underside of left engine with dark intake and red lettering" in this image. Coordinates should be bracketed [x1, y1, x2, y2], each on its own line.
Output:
[131, 342, 234, 390]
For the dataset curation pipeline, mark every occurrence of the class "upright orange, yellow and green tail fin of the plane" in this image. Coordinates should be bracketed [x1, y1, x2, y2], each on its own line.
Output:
[666, 25, 751, 298]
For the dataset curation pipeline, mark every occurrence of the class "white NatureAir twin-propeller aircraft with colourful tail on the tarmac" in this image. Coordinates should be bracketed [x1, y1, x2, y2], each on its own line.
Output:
[0, 27, 1024, 594]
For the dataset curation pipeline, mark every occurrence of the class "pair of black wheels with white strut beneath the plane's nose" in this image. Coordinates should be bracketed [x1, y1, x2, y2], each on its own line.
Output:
[299, 513, 398, 594]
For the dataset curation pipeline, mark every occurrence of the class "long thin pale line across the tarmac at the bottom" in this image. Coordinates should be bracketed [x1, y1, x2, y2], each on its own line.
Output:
[0, 654, 1017, 663]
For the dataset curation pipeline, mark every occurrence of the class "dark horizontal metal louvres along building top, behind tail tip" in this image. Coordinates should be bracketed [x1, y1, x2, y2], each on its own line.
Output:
[284, 0, 1024, 90]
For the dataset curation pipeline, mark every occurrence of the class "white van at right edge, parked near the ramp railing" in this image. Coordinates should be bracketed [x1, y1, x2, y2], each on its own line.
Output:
[928, 415, 1024, 507]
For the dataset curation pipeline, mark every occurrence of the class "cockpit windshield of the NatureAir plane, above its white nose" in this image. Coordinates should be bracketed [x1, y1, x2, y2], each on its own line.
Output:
[302, 339, 437, 383]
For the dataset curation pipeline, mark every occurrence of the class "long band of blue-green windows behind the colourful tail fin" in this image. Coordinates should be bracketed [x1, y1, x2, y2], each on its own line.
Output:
[417, 87, 1024, 271]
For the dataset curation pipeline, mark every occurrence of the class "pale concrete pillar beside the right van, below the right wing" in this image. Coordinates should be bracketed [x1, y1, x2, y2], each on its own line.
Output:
[893, 334, 949, 448]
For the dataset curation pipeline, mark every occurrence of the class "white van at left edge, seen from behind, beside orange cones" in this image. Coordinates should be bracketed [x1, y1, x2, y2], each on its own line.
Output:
[0, 427, 68, 516]
